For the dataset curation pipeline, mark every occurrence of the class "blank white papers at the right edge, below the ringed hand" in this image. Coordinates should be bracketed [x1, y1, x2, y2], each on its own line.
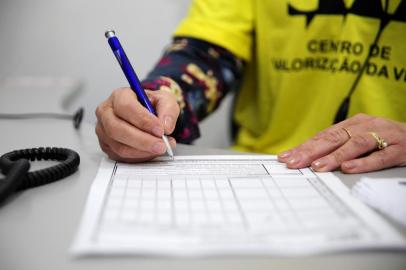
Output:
[353, 177, 406, 226]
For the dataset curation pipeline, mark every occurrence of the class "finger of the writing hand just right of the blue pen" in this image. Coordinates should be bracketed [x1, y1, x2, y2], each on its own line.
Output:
[148, 91, 180, 134]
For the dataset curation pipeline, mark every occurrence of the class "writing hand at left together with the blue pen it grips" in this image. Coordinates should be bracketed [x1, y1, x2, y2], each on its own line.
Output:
[96, 31, 179, 162]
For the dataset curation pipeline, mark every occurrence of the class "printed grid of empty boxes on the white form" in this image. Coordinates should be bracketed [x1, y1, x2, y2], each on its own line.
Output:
[103, 162, 359, 236]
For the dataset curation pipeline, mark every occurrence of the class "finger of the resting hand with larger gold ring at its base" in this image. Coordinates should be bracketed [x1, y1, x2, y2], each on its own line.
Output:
[311, 132, 376, 172]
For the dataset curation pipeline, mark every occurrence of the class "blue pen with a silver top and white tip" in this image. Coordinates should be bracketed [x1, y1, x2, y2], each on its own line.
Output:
[105, 30, 173, 159]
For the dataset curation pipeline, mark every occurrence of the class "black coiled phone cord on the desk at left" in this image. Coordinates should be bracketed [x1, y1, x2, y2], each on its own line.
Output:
[0, 147, 80, 203]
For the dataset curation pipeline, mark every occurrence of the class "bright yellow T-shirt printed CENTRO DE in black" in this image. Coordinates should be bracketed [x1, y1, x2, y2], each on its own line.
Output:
[175, 0, 406, 153]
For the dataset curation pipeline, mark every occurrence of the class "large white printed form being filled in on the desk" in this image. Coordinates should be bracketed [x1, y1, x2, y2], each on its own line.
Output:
[72, 155, 406, 256]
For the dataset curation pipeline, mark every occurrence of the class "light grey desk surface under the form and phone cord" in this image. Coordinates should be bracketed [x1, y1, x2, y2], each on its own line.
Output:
[0, 120, 406, 270]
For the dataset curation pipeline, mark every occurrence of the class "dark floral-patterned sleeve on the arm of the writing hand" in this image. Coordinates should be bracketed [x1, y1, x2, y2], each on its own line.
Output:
[142, 37, 244, 144]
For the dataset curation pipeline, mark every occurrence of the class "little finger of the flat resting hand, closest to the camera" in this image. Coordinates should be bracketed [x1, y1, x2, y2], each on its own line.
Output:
[341, 145, 402, 173]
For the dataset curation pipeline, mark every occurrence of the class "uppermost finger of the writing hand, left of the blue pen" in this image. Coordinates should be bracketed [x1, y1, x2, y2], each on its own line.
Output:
[112, 88, 164, 137]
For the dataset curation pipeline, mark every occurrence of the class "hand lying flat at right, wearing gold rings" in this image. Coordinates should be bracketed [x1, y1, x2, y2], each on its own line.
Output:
[278, 114, 406, 173]
